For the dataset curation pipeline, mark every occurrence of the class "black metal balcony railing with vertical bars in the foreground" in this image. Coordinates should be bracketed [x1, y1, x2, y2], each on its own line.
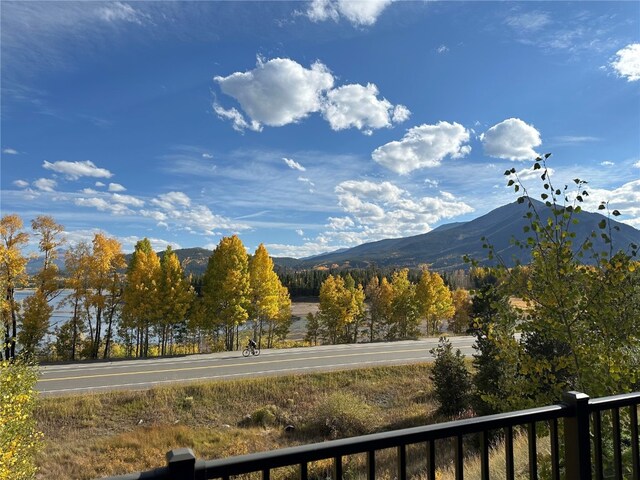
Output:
[105, 392, 640, 480]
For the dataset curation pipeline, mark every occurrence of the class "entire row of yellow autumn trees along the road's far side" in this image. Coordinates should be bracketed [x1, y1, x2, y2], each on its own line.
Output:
[0, 215, 470, 360]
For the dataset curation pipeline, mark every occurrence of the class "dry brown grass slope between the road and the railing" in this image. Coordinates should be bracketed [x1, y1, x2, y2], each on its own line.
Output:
[36, 364, 438, 479]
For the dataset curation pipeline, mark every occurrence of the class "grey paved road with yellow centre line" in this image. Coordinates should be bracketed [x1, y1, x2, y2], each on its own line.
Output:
[36, 337, 474, 395]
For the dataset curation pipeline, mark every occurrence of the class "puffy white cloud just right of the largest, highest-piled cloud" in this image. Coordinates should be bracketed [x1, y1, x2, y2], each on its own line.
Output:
[322, 83, 411, 133]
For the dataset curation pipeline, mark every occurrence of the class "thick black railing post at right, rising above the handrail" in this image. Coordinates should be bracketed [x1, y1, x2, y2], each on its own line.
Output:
[562, 392, 591, 480]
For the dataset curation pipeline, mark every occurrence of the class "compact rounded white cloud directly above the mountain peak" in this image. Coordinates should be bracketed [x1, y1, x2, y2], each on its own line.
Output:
[480, 118, 542, 160]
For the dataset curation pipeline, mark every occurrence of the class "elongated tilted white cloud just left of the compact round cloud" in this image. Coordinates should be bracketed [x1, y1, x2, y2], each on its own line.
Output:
[371, 122, 471, 174]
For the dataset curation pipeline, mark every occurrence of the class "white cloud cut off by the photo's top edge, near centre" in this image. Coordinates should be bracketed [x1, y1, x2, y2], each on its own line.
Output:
[307, 0, 392, 26]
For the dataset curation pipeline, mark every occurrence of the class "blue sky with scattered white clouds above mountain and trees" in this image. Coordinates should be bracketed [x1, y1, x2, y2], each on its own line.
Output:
[1, 0, 640, 257]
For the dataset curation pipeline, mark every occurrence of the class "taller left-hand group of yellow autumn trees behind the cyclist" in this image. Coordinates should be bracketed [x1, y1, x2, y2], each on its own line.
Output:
[0, 215, 291, 360]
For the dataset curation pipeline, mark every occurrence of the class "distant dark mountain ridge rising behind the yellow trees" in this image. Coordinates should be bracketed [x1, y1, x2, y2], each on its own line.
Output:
[28, 200, 640, 275]
